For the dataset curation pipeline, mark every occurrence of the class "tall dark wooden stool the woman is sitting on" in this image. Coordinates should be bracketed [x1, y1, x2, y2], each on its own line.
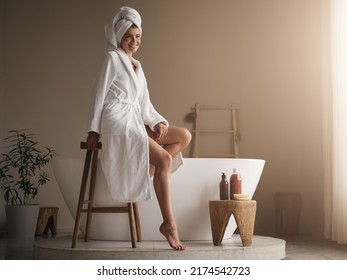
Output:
[72, 142, 141, 248]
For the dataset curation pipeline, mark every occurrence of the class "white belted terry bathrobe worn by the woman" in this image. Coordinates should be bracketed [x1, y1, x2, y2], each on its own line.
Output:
[89, 48, 182, 202]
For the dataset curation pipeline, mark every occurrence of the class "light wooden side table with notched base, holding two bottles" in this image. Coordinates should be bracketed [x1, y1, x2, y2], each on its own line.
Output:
[209, 200, 257, 246]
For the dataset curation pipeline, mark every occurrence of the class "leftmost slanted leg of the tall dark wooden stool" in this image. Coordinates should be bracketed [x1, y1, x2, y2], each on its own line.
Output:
[71, 151, 92, 248]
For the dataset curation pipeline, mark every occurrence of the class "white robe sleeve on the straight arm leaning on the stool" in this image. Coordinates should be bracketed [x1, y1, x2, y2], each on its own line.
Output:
[88, 52, 116, 134]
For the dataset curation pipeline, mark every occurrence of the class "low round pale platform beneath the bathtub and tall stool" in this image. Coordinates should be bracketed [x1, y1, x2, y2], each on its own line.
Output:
[33, 234, 285, 260]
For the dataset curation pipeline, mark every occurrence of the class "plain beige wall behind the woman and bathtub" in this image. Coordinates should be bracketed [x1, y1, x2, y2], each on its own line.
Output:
[0, 0, 323, 236]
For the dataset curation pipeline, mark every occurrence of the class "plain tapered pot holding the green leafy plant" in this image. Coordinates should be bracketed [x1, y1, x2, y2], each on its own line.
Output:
[5, 204, 40, 238]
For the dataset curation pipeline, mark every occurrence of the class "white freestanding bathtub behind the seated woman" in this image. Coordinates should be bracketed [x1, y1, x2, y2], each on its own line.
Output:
[52, 158, 265, 240]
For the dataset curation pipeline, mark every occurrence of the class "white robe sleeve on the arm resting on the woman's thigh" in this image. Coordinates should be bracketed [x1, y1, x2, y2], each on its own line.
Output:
[140, 67, 169, 131]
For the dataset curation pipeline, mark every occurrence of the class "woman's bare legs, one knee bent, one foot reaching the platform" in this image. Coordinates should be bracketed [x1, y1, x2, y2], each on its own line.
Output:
[148, 124, 191, 250]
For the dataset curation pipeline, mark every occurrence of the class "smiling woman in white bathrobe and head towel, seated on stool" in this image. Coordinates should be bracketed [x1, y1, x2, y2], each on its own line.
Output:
[87, 7, 191, 250]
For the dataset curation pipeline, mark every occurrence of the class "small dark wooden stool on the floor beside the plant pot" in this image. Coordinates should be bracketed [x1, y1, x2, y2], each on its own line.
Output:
[36, 207, 59, 235]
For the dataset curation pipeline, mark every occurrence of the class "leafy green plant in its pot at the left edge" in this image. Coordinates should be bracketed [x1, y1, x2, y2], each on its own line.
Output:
[0, 130, 55, 238]
